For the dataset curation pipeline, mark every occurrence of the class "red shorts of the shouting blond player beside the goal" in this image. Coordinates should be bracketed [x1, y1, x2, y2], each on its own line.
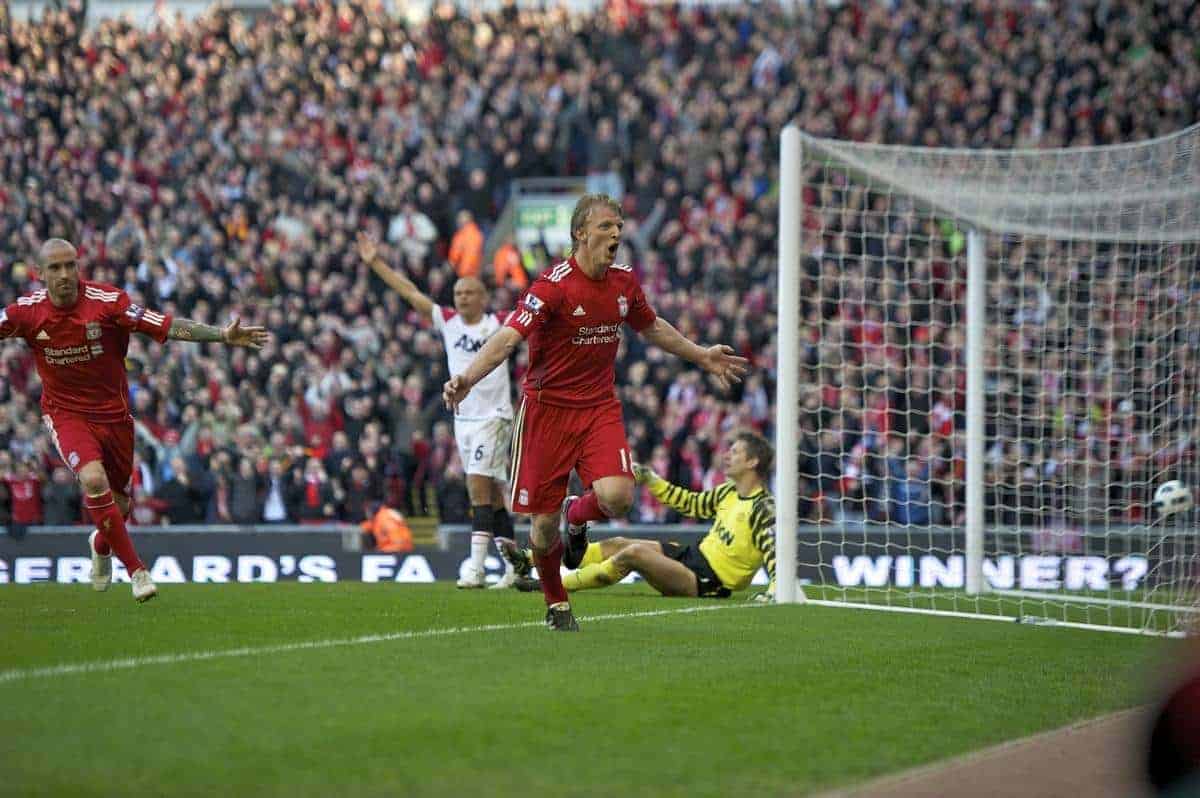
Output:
[510, 396, 634, 514]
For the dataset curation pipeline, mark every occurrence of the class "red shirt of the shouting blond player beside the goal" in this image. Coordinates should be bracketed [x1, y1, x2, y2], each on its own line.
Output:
[505, 258, 658, 407]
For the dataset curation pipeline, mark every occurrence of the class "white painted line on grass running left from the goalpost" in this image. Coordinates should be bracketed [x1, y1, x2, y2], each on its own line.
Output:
[0, 602, 767, 684]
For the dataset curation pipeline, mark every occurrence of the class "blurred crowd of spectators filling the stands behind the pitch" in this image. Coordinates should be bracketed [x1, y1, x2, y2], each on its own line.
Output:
[0, 0, 1200, 532]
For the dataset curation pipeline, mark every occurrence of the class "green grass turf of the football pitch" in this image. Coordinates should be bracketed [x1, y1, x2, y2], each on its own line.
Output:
[0, 583, 1172, 798]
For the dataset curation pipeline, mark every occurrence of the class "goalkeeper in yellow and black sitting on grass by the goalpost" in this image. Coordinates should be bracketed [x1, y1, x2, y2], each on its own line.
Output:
[496, 432, 775, 600]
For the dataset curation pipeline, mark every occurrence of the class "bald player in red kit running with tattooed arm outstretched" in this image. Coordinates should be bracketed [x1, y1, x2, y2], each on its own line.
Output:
[0, 239, 268, 601]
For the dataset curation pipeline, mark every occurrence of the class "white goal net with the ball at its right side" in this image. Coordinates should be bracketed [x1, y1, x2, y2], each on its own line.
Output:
[776, 126, 1200, 634]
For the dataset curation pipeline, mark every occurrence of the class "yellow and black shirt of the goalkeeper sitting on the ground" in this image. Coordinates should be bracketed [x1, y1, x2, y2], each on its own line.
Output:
[649, 476, 775, 590]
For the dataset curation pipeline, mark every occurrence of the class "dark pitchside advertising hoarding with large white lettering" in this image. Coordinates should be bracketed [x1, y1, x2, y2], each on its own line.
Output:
[0, 533, 1157, 592]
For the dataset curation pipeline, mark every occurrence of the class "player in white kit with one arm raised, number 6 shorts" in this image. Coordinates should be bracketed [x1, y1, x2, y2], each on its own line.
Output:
[359, 233, 536, 589]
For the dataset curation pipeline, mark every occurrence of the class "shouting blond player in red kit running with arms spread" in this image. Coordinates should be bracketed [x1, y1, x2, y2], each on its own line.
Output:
[443, 194, 748, 631]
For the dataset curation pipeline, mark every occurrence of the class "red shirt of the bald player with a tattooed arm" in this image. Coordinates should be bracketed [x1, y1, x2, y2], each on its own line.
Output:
[0, 280, 170, 422]
